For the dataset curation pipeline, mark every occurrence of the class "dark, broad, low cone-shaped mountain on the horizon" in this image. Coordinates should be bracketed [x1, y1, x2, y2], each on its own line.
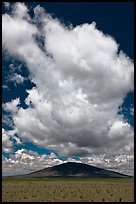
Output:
[25, 162, 131, 178]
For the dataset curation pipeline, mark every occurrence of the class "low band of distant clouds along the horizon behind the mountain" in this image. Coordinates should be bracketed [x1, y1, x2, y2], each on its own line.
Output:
[2, 149, 134, 176]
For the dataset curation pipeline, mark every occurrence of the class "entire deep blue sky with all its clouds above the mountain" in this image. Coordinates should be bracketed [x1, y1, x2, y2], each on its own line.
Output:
[2, 2, 134, 175]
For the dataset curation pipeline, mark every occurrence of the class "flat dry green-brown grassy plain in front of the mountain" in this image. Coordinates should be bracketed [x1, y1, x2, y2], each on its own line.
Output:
[2, 178, 134, 202]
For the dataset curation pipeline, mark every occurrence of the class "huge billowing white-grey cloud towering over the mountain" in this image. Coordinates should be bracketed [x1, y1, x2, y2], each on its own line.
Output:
[2, 3, 134, 172]
